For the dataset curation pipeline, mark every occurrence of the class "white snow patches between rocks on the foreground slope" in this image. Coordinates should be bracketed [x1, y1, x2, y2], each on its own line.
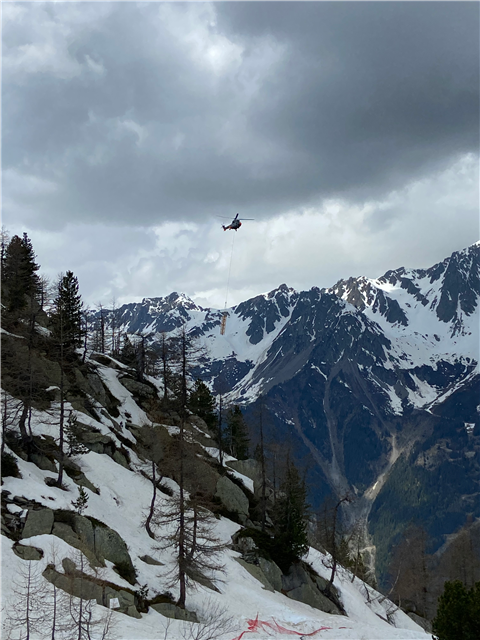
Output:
[0, 365, 429, 640]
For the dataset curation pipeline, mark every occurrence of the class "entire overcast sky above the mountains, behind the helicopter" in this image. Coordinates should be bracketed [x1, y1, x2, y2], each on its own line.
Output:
[2, 0, 479, 308]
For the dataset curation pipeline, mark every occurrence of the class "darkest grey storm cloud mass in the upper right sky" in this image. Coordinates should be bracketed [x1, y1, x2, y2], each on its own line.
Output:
[218, 2, 479, 193]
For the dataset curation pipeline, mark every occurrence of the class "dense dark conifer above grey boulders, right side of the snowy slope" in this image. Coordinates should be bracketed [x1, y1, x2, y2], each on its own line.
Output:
[273, 460, 309, 571]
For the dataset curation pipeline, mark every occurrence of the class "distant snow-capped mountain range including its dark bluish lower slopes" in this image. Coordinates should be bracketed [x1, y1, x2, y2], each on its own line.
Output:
[106, 243, 480, 572]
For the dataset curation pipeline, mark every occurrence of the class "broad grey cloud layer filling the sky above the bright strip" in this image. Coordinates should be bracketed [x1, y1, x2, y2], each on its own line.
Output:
[3, 3, 479, 227]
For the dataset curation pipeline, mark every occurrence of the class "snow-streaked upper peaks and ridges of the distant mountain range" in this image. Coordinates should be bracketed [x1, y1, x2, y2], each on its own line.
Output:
[111, 243, 480, 413]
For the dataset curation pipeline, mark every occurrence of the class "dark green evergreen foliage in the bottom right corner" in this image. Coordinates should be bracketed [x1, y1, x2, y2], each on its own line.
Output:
[433, 580, 480, 640]
